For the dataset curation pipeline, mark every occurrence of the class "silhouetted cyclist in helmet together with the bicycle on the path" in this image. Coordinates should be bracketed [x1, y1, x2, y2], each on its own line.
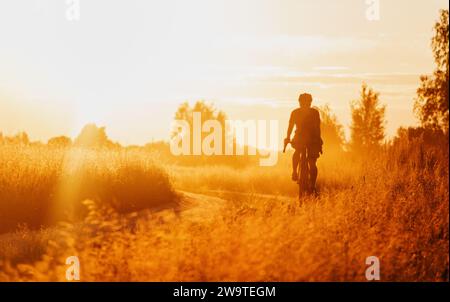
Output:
[284, 93, 323, 195]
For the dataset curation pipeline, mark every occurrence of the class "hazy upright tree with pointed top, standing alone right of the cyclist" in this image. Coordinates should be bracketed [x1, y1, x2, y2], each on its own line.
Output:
[350, 84, 386, 152]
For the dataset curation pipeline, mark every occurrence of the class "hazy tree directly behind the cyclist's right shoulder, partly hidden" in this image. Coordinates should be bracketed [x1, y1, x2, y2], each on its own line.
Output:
[319, 105, 345, 154]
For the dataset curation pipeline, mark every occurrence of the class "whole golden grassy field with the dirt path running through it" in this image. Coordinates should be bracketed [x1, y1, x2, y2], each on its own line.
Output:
[0, 131, 449, 281]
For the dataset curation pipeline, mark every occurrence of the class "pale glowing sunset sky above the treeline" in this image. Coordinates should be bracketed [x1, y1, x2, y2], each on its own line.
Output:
[0, 0, 448, 144]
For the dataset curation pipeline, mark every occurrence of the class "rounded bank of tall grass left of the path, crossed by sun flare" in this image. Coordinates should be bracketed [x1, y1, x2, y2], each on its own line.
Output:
[0, 145, 177, 233]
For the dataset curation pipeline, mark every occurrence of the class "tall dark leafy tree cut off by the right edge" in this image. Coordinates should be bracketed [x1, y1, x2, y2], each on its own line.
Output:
[414, 10, 449, 133]
